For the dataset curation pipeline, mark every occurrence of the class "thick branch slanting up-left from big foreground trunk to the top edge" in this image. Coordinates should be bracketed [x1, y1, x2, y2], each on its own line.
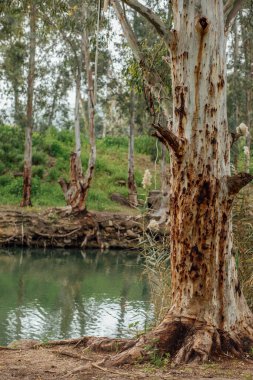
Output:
[120, 0, 172, 45]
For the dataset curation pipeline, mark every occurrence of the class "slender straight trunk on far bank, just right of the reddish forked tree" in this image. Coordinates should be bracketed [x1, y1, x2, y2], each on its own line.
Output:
[127, 90, 138, 207]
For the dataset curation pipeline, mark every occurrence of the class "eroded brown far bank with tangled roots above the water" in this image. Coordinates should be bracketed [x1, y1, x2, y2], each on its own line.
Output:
[0, 207, 167, 249]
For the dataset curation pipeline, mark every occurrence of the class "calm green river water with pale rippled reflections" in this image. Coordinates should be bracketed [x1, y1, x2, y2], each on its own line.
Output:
[0, 249, 152, 345]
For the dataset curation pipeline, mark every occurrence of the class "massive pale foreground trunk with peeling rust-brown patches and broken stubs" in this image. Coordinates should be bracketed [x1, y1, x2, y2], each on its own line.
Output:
[112, 0, 253, 364]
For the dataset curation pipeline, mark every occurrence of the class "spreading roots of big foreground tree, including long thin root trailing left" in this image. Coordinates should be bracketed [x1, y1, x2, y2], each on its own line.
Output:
[36, 317, 253, 367]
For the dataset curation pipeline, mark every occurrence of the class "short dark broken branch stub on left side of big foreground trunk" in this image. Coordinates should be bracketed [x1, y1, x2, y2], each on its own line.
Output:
[152, 124, 186, 158]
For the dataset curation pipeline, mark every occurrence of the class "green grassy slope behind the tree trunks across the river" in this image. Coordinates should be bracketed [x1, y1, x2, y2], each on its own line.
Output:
[0, 126, 160, 212]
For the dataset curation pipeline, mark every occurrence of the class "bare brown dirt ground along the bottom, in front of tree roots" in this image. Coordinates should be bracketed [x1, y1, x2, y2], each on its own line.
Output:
[0, 345, 253, 380]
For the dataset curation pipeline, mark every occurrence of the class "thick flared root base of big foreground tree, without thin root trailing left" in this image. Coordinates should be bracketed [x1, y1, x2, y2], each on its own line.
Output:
[99, 321, 253, 366]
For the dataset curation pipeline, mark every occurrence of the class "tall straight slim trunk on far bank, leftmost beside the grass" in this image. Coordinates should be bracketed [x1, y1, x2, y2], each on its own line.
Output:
[20, 1, 36, 207]
